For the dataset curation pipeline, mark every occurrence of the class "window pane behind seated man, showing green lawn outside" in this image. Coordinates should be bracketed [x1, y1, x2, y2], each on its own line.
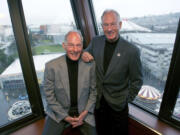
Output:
[22, 0, 76, 108]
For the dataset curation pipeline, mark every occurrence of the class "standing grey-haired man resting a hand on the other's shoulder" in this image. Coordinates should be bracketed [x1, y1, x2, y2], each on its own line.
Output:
[82, 10, 143, 135]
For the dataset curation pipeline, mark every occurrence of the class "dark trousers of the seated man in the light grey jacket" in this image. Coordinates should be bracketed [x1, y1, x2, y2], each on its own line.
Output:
[42, 116, 96, 135]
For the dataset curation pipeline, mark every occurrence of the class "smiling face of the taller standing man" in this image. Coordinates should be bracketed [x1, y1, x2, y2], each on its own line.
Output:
[102, 12, 121, 42]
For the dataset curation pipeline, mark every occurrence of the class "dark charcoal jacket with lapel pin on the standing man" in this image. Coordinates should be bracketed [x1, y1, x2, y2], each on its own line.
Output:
[86, 36, 143, 111]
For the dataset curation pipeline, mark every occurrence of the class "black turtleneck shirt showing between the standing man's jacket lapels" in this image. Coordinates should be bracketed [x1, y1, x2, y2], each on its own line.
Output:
[103, 38, 119, 75]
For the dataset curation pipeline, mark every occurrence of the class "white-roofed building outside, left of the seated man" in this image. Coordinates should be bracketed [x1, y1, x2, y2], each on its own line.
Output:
[0, 53, 64, 91]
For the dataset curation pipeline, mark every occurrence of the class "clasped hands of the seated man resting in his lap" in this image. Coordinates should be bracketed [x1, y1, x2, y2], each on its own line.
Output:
[65, 110, 88, 128]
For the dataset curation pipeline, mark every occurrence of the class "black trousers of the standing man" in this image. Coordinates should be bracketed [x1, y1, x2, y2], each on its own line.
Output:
[95, 97, 128, 135]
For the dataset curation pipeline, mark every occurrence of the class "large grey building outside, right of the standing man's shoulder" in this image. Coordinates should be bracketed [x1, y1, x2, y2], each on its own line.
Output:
[121, 33, 175, 81]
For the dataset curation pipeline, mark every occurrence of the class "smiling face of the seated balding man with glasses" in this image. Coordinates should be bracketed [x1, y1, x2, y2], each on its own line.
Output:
[63, 32, 83, 61]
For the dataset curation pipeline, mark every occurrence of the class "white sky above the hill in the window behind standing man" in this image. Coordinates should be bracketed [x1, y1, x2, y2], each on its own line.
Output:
[93, 0, 180, 17]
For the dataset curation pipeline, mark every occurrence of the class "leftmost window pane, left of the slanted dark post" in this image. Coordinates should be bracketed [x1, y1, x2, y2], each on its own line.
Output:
[0, 0, 31, 126]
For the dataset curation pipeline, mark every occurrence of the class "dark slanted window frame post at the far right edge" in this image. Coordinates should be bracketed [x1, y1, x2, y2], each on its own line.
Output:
[158, 19, 180, 129]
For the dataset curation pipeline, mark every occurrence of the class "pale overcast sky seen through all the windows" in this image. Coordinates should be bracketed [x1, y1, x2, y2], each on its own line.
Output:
[0, 0, 180, 24]
